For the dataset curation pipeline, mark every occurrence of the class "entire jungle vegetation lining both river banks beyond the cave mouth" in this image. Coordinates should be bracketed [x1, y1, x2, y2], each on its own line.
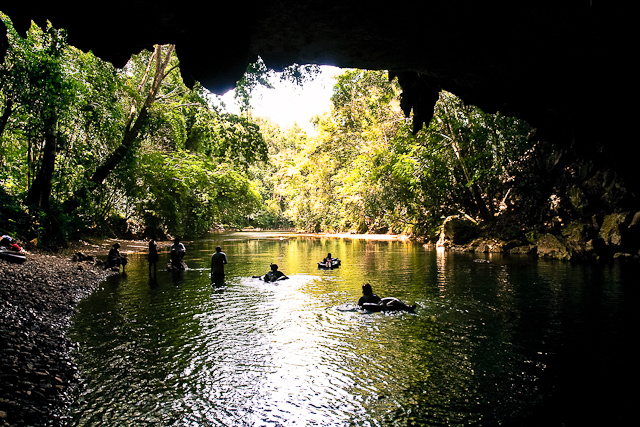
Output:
[0, 14, 535, 247]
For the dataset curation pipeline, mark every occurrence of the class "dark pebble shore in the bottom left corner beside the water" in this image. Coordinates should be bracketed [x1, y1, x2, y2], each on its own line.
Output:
[0, 254, 118, 427]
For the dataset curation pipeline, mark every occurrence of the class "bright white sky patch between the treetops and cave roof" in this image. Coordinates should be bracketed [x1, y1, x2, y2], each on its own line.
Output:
[222, 65, 342, 135]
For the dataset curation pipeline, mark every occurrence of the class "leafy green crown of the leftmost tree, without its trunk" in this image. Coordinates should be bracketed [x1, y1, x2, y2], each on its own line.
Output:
[0, 15, 75, 194]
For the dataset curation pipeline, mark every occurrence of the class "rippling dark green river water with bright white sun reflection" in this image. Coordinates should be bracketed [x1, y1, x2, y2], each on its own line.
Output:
[68, 233, 638, 426]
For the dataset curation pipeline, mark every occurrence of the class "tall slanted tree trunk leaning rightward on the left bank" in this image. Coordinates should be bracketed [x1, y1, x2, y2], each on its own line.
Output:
[64, 45, 175, 213]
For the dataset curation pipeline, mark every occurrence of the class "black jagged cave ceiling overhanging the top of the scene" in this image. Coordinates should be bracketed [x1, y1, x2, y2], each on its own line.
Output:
[0, 0, 635, 155]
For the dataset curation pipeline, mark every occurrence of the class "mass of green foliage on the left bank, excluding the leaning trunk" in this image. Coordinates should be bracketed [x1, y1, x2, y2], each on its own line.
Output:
[0, 15, 267, 239]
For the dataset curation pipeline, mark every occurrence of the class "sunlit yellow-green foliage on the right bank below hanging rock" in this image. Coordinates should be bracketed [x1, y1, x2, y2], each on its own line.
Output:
[250, 70, 531, 236]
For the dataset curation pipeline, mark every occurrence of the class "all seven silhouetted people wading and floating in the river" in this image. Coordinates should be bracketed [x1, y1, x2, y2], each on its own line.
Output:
[105, 238, 416, 312]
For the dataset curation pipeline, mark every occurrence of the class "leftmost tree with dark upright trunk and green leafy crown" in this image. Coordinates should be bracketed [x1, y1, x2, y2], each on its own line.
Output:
[0, 15, 75, 212]
